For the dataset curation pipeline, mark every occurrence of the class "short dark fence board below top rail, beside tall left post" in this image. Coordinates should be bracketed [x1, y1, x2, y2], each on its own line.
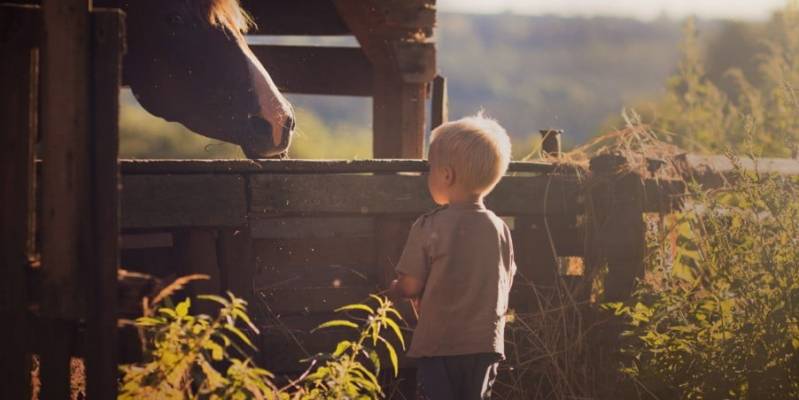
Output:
[122, 175, 247, 228]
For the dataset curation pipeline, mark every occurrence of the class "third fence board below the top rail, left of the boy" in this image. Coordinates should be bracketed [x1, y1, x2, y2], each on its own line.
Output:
[253, 237, 375, 269]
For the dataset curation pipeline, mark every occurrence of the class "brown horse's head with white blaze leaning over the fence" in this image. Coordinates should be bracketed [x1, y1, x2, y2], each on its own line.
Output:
[121, 0, 294, 158]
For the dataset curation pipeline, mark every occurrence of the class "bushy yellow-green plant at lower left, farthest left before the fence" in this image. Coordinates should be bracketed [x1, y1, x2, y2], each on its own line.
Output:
[120, 294, 278, 399]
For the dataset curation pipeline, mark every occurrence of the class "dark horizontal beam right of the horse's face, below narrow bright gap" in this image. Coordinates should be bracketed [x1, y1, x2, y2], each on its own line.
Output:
[250, 46, 373, 96]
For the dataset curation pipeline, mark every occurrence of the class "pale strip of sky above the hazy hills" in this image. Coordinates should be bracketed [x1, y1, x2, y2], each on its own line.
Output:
[438, 0, 786, 20]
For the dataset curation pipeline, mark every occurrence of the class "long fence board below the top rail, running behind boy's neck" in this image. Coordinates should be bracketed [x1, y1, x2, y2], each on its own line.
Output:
[250, 175, 580, 215]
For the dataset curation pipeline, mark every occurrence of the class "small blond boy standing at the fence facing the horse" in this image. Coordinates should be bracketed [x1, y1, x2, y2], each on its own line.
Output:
[391, 115, 516, 400]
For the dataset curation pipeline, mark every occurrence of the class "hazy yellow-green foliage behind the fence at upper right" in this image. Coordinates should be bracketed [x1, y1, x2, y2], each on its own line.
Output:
[620, 1, 799, 157]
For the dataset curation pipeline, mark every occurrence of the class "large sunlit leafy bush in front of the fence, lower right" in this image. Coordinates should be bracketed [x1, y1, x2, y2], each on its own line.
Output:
[609, 164, 799, 399]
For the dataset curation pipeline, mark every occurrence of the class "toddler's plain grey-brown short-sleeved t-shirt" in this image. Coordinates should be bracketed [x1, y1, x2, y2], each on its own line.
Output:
[396, 204, 516, 357]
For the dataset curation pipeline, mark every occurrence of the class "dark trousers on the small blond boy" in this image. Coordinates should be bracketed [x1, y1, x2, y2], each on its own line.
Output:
[416, 353, 500, 400]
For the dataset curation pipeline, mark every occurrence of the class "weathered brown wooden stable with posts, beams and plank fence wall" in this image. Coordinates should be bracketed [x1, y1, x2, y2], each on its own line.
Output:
[0, 0, 793, 399]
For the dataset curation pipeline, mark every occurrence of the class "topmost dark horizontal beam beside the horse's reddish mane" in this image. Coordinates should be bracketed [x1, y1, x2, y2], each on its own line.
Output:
[241, 0, 350, 36]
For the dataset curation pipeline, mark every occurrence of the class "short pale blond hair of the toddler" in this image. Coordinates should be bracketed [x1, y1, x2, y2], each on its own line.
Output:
[428, 113, 511, 194]
